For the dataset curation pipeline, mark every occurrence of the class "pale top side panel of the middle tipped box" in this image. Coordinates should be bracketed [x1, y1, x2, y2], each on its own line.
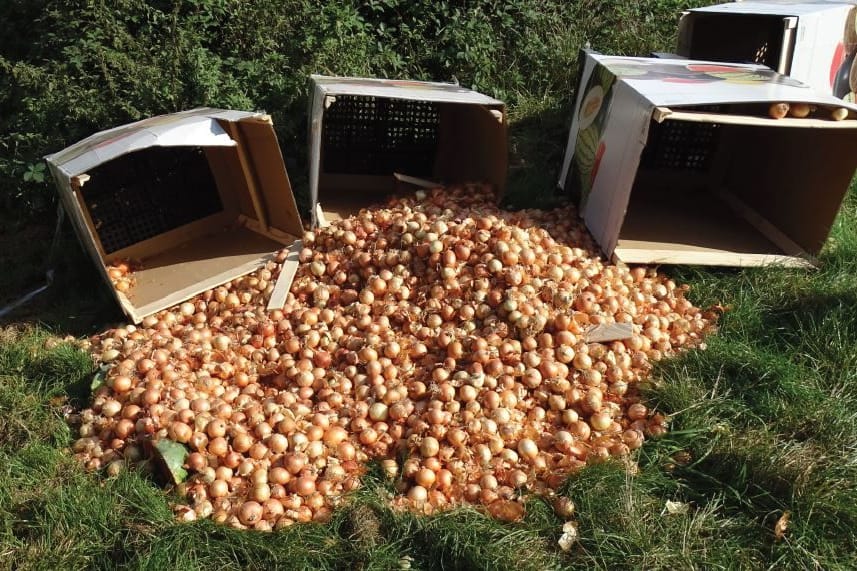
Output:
[310, 75, 505, 107]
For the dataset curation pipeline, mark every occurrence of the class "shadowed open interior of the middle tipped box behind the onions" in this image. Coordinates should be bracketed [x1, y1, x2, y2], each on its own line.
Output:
[317, 95, 507, 221]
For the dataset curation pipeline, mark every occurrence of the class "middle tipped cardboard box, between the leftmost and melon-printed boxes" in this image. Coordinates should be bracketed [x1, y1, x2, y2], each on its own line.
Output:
[309, 75, 508, 225]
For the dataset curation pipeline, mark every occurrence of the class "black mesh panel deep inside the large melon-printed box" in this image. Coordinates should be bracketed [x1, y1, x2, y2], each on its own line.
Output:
[641, 109, 720, 172]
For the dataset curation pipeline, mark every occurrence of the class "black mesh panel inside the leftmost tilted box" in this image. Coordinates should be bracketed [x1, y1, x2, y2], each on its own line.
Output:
[81, 147, 223, 254]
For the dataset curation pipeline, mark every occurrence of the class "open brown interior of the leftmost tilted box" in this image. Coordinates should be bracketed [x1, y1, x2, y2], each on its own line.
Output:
[72, 121, 301, 322]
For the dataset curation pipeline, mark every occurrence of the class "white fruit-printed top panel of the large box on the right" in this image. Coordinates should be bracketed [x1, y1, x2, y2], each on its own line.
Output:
[588, 53, 857, 111]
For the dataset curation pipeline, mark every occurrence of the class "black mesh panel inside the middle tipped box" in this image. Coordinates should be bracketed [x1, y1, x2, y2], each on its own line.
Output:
[322, 95, 440, 176]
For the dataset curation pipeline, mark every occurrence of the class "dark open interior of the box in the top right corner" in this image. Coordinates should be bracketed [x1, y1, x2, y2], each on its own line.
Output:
[679, 12, 796, 75]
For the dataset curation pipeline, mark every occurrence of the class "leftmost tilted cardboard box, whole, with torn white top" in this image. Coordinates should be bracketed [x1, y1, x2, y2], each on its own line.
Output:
[46, 109, 303, 323]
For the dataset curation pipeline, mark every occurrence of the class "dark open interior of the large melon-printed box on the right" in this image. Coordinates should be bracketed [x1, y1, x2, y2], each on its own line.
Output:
[614, 108, 857, 266]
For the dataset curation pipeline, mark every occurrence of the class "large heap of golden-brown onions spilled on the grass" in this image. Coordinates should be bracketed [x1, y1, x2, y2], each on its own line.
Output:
[74, 185, 714, 530]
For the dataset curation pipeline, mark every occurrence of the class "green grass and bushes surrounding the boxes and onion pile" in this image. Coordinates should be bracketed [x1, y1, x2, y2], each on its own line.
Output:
[6, 0, 857, 569]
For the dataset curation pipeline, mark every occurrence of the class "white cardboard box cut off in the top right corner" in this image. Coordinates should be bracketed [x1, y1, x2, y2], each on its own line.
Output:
[678, 0, 857, 101]
